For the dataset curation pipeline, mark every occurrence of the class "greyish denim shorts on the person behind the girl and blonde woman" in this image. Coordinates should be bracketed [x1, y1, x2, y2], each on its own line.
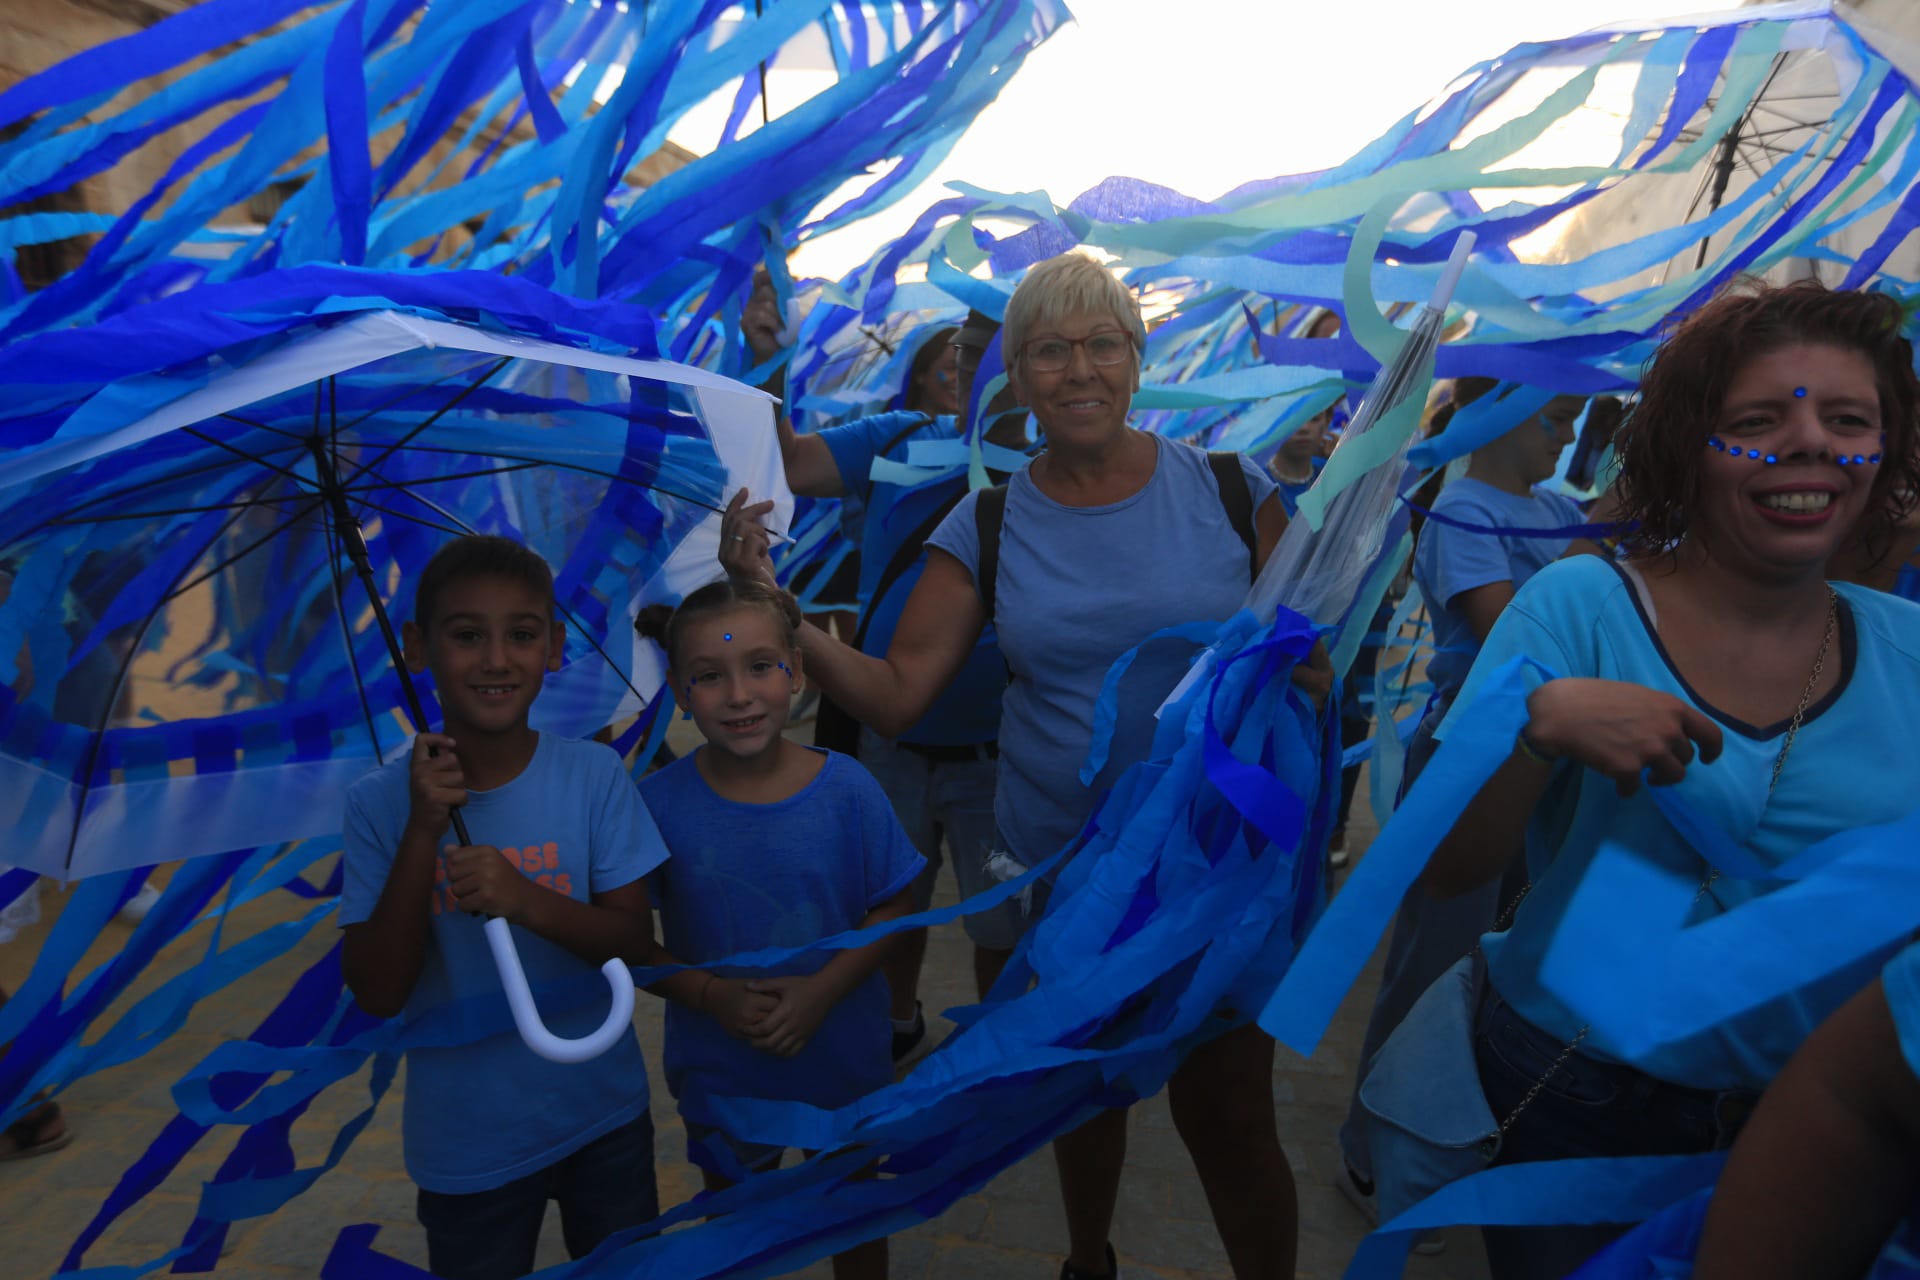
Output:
[860, 727, 1025, 952]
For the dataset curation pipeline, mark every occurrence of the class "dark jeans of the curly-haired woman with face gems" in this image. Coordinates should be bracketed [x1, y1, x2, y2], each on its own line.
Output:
[1473, 986, 1759, 1280]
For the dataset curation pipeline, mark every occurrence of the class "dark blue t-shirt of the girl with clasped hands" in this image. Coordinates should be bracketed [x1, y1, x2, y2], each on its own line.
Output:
[639, 752, 927, 1125]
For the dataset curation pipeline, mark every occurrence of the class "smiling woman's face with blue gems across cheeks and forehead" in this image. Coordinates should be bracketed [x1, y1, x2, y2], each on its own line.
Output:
[1695, 344, 1882, 570]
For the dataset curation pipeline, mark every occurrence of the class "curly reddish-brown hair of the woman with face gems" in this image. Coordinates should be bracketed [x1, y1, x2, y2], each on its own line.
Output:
[1613, 278, 1920, 555]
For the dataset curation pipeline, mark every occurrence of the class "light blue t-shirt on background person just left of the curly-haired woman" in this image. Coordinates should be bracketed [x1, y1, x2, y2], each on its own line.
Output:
[1413, 476, 1584, 704]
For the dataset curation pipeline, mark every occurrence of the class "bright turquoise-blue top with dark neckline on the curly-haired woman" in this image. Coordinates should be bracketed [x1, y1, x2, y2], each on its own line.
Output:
[1438, 557, 1920, 1088]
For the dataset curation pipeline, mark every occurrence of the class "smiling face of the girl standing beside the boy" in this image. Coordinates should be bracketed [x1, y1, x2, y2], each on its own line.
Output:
[668, 604, 801, 758]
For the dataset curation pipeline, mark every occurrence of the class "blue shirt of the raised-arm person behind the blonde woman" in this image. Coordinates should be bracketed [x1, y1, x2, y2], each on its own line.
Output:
[820, 411, 1006, 747]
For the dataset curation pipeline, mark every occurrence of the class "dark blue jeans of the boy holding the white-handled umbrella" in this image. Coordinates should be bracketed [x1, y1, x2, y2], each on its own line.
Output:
[417, 1111, 660, 1280]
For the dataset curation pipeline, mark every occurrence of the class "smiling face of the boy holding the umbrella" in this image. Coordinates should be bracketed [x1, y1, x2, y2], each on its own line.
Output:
[405, 574, 566, 739]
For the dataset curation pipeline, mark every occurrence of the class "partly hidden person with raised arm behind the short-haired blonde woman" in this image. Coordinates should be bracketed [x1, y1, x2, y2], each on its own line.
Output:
[743, 284, 1027, 1067]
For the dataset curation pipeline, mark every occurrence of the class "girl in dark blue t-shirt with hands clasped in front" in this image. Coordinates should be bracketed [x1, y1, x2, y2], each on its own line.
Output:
[636, 580, 925, 1280]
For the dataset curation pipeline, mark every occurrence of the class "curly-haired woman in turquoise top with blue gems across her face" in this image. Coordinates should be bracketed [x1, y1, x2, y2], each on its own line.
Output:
[1425, 282, 1920, 1280]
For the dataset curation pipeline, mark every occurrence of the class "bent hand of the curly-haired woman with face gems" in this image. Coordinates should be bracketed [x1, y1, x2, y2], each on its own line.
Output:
[1526, 679, 1720, 796]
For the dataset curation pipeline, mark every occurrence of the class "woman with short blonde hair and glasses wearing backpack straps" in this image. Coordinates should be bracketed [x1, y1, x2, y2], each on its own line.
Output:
[720, 253, 1331, 1280]
